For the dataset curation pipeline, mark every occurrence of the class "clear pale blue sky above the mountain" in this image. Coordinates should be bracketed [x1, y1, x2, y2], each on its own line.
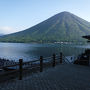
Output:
[0, 0, 90, 34]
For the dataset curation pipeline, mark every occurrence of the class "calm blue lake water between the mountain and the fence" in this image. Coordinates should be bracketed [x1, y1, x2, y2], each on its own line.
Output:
[0, 43, 90, 61]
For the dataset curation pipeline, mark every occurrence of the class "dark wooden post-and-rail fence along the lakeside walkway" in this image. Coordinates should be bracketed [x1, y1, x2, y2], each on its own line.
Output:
[0, 53, 70, 81]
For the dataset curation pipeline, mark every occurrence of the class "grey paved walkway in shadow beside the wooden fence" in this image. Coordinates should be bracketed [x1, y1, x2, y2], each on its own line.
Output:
[0, 64, 90, 90]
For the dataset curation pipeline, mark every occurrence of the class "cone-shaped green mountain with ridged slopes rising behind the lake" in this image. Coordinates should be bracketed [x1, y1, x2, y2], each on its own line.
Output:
[0, 12, 90, 42]
